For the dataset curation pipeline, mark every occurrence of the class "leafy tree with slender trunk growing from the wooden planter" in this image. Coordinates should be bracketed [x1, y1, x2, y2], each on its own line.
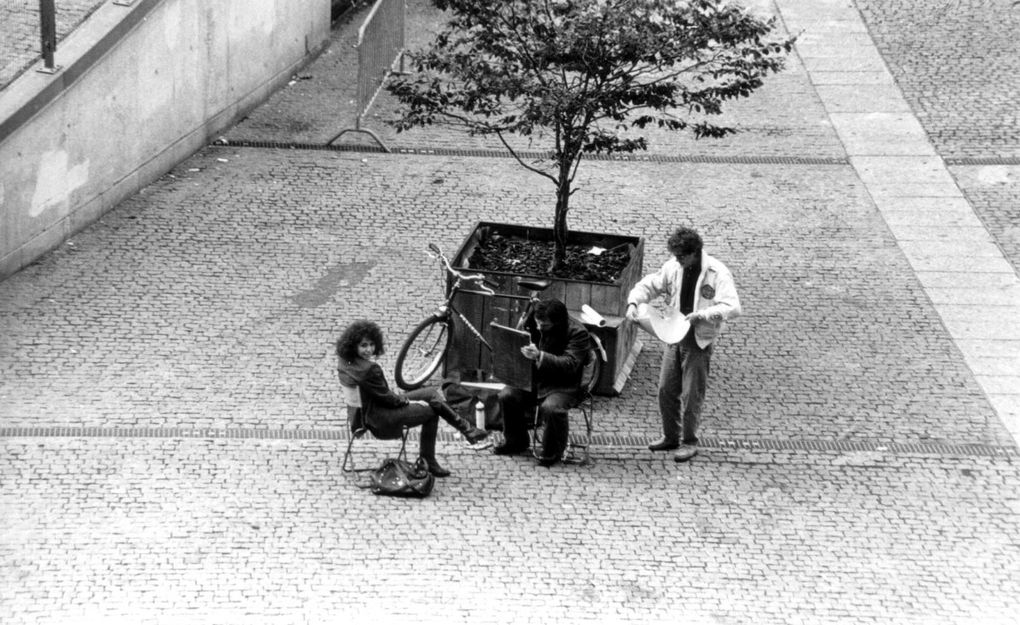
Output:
[388, 0, 794, 271]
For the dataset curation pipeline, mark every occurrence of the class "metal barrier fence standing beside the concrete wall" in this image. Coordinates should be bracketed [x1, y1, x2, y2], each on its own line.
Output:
[326, 0, 406, 152]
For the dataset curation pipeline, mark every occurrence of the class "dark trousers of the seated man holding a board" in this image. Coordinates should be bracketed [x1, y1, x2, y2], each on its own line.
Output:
[499, 386, 577, 458]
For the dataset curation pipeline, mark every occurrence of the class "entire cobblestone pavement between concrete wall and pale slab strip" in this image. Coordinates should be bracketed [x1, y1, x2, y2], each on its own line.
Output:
[0, 2, 1020, 624]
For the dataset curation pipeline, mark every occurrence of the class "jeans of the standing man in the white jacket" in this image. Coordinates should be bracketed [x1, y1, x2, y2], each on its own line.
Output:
[659, 329, 712, 445]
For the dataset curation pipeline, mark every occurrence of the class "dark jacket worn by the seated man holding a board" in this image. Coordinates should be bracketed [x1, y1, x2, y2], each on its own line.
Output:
[524, 318, 591, 398]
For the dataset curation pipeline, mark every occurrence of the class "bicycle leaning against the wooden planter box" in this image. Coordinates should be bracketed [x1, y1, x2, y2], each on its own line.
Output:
[394, 243, 552, 390]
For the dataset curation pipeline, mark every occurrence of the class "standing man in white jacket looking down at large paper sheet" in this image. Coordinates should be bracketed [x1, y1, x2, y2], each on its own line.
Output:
[627, 227, 741, 462]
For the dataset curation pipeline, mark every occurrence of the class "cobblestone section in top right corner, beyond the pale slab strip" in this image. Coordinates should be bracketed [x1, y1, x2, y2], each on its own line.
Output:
[855, 0, 1020, 158]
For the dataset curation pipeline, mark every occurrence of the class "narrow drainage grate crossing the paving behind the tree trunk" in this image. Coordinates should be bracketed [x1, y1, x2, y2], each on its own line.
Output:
[212, 139, 850, 166]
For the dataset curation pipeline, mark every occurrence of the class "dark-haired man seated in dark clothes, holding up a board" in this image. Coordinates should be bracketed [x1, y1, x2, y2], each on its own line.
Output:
[493, 300, 591, 467]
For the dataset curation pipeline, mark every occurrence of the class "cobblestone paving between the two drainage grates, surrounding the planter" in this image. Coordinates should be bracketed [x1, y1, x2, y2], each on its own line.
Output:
[0, 148, 1009, 445]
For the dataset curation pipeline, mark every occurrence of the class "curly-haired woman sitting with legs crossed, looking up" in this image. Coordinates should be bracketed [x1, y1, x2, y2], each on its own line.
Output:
[337, 321, 489, 477]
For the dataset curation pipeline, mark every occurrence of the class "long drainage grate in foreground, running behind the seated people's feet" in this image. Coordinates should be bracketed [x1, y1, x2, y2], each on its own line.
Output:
[0, 426, 1020, 458]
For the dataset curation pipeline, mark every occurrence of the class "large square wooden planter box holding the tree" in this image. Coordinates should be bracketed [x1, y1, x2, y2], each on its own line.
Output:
[446, 221, 645, 395]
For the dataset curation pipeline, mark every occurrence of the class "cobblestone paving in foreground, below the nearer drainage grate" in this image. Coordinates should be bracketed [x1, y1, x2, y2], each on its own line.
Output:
[0, 439, 1020, 625]
